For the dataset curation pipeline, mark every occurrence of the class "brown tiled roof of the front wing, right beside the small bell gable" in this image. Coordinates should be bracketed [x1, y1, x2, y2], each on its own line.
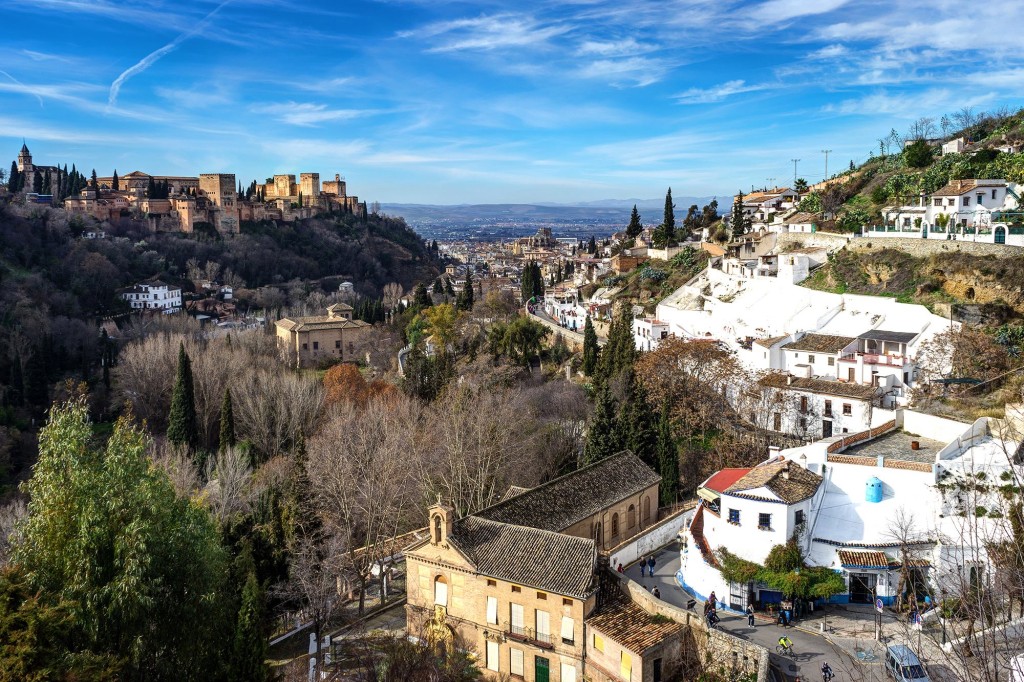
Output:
[449, 516, 597, 599]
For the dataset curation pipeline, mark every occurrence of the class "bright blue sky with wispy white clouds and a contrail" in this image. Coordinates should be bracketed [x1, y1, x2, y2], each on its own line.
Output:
[0, 0, 1024, 204]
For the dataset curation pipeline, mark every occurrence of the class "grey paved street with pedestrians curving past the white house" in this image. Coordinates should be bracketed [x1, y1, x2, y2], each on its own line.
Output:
[626, 544, 887, 682]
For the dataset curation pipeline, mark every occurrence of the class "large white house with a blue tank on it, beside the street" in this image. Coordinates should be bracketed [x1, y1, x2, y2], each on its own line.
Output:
[678, 406, 1024, 608]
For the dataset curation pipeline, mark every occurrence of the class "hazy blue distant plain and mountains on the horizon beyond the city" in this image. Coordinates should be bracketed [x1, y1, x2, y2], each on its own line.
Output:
[381, 197, 713, 240]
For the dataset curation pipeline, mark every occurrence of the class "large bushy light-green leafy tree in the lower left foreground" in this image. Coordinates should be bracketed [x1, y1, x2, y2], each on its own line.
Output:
[12, 398, 233, 680]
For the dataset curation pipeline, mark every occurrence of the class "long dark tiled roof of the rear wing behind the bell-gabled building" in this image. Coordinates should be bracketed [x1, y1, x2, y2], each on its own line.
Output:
[475, 451, 662, 532]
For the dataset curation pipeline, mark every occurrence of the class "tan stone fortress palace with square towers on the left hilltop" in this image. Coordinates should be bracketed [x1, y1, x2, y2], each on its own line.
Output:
[17, 144, 367, 233]
